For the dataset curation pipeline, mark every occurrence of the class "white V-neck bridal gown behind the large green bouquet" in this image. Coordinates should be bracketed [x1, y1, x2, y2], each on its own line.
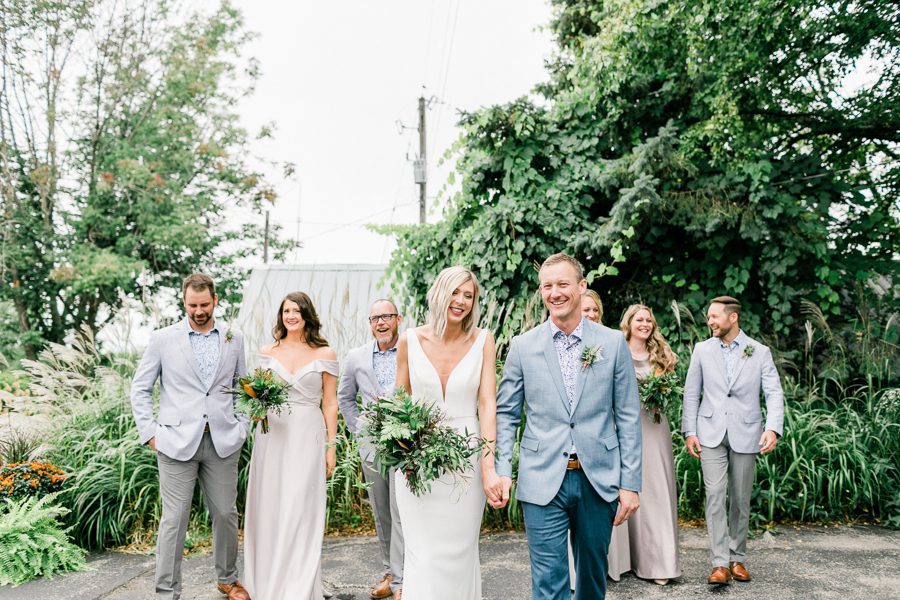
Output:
[395, 329, 487, 600]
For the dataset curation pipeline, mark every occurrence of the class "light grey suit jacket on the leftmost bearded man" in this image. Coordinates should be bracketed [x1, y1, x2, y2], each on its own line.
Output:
[131, 319, 249, 460]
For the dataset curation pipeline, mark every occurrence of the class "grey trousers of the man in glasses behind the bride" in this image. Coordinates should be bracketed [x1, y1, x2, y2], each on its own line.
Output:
[362, 459, 403, 590]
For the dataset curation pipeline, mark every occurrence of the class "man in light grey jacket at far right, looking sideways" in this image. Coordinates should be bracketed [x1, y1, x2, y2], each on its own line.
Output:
[681, 296, 784, 585]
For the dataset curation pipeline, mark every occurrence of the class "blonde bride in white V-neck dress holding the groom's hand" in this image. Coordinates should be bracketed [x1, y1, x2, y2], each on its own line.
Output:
[396, 267, 501, 600]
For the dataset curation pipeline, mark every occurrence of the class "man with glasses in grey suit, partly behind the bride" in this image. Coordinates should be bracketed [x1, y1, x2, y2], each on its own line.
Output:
[338, 300, 403, 599]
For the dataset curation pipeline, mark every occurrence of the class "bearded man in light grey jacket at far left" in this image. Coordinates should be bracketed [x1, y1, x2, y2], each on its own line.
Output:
[131, 273, 250, 600]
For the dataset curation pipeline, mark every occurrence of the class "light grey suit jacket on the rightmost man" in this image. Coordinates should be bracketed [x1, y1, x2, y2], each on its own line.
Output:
[681, 331, 784, 454]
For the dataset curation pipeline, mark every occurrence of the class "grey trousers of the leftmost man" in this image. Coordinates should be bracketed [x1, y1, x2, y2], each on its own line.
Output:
[156, 432, 241, 600]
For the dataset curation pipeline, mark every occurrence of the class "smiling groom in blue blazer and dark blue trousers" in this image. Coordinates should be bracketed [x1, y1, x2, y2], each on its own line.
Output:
[486, 254, 641, 600]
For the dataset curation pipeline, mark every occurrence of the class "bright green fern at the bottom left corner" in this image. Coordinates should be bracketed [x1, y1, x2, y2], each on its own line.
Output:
[0, 494, 86, 585]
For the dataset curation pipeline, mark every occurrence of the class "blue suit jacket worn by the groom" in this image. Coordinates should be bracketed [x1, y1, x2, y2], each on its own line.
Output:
[496, 320, 641, 506]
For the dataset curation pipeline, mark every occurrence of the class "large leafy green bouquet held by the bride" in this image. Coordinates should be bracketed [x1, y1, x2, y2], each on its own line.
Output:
[361, 388, 485, 496]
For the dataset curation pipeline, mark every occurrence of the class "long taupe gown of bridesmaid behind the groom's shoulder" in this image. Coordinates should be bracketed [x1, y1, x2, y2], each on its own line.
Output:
[609, 358, 681, 581]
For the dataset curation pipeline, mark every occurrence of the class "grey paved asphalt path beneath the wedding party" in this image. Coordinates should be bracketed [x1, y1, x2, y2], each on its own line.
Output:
[0, 527, 900, 600]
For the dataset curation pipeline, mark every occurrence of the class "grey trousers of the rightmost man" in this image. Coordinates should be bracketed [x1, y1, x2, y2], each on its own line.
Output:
[700, 434, 756, 567]
